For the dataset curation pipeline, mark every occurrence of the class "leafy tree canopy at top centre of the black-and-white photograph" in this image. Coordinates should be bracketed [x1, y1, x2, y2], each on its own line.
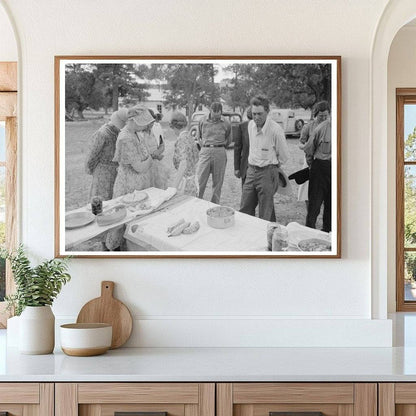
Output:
[147, 63, 219, 121]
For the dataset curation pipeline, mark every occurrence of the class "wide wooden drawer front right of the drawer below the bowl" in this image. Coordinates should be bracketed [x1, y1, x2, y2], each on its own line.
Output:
[217, 383, 376, 416]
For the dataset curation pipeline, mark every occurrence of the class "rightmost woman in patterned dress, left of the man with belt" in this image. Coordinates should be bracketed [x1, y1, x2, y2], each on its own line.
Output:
[170, 111, 199, 196]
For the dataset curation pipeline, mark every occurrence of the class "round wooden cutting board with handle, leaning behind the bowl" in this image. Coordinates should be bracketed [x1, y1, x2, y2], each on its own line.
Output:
[77, 281, 133, 349]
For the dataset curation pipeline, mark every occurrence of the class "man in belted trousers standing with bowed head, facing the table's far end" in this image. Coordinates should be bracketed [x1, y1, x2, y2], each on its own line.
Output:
[196, 102, 231, 204]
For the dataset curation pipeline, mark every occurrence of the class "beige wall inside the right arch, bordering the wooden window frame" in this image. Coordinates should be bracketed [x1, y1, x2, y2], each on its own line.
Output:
[387, 25, 416, 312]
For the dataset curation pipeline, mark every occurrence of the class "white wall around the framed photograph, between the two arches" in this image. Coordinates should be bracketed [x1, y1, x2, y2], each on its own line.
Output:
[0, 0, 391, 346]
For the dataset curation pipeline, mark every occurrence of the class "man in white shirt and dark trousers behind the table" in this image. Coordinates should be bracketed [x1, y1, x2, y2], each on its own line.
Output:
[240, 96, 289, 222]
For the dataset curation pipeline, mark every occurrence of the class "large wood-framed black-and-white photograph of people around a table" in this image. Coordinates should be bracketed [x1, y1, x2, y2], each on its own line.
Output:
[55, 56, 341, 258]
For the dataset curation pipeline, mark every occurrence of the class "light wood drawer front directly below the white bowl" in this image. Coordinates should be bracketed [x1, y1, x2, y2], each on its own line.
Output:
[55, 383, 215, 416]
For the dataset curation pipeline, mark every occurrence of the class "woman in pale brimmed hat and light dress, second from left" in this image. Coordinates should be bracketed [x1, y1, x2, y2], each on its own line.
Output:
[113, 107, 154, 198]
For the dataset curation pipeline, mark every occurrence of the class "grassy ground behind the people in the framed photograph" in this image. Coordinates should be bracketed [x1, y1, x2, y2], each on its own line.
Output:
[65, 119, 321, 227]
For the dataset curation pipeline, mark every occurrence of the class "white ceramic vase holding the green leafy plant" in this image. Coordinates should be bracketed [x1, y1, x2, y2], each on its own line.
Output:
[19, 306, 55, 354]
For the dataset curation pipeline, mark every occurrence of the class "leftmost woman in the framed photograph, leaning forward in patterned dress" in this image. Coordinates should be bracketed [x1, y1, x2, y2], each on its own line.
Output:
[85, 108, 127, 201]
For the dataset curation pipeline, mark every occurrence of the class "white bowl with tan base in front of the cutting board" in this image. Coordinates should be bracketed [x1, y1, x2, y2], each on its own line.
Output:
[60, 323, 113, 357]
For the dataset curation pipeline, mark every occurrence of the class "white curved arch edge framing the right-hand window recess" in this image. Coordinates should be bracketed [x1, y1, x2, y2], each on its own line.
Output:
[371, 0, 416, 319]
